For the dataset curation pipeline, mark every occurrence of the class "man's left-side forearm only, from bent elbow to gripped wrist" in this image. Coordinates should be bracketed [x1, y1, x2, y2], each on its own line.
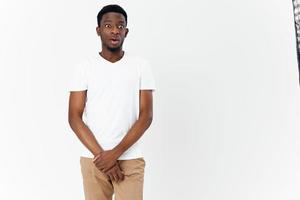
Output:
[69, 117, 103, 156]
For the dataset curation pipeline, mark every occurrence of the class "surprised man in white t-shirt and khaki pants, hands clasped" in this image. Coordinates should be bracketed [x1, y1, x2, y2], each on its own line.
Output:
[68, 5, 155, 200]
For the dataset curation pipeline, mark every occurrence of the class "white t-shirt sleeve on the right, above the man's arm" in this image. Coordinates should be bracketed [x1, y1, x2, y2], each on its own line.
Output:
[140, 61, 156, 91]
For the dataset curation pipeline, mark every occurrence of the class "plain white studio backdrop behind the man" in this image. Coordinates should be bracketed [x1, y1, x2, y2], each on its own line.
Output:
[0, 0, 300, 200]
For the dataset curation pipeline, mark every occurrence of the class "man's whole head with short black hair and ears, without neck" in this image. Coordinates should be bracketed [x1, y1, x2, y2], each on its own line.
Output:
[96, 5, 128, 51]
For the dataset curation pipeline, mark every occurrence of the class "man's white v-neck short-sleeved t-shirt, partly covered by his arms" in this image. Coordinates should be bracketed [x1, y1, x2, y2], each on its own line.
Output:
[68, 52, 155, 160]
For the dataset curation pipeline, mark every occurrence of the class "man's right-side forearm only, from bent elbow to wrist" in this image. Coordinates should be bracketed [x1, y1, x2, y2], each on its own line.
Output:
[114, 115, 152, 156]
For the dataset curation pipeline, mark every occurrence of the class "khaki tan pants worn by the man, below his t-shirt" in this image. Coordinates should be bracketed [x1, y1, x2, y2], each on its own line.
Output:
[80, 156, 145, 200]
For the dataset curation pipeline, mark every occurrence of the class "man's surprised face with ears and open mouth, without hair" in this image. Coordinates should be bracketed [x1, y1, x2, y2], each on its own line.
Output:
[96, 12, 128, 51]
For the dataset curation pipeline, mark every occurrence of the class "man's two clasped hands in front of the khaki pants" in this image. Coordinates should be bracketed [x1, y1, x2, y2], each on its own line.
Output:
[93, 150, 124, 182]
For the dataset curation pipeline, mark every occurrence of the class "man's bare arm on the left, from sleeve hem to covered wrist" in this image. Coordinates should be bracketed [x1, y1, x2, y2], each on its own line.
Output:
[68, 90, 103, 156]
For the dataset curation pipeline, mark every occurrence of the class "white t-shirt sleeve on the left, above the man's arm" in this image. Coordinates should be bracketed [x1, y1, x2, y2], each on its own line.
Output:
[68, 63, 88, 92]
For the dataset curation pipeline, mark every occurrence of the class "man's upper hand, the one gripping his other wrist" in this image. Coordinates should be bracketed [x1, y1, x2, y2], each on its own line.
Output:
[93, 150, 118, 173]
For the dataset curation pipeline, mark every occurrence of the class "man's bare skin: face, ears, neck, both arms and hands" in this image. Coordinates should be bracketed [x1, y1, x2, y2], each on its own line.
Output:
[68, 12, 153, 182]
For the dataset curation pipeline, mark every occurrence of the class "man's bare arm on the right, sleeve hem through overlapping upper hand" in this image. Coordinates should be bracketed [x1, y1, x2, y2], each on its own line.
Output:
[94, 90, 153, 172]
